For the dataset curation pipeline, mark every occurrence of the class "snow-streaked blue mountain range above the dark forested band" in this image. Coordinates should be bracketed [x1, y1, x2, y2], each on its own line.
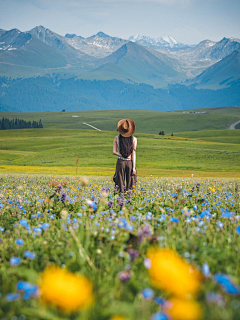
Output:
[0, 26, 240, 111]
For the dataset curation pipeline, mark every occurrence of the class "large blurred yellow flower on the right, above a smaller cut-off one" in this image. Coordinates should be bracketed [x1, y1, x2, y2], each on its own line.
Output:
[147, 248, 202, 298]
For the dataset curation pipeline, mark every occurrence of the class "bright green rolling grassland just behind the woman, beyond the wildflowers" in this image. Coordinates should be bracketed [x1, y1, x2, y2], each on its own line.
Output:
[0, 129, 240, 177]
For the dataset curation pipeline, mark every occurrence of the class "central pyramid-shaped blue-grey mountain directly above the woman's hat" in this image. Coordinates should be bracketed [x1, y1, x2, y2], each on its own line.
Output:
[87, 41, 183, 87]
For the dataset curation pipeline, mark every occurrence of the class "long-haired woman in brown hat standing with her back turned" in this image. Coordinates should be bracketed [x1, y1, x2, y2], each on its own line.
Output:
[113, 119, 137, 192]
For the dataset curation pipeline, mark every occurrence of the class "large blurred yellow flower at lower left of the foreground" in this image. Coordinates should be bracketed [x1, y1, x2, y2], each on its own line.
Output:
[40, 266, 93, 313]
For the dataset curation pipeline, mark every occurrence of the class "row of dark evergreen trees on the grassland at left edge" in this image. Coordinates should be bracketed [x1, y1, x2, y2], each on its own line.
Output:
[0, 117, 43, 130]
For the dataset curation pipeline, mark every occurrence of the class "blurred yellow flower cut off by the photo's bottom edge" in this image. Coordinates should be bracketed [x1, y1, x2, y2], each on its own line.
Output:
[163, 298, 202, 320]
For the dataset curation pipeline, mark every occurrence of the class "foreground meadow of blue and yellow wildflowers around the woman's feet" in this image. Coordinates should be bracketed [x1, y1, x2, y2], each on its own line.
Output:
[0, 174, 240, 320]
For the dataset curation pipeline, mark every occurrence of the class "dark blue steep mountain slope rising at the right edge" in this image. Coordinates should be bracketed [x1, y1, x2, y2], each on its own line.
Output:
[186, 50, 240, 89]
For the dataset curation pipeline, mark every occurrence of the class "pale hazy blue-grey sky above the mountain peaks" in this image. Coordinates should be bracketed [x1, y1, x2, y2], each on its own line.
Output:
[0, 0, 240, 44]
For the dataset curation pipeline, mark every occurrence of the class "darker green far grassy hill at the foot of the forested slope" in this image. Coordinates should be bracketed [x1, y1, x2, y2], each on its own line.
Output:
[0, 108, 240, 135]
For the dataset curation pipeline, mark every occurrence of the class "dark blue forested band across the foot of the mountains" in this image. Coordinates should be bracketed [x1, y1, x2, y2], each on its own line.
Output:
[0, 75, 240, 112]
